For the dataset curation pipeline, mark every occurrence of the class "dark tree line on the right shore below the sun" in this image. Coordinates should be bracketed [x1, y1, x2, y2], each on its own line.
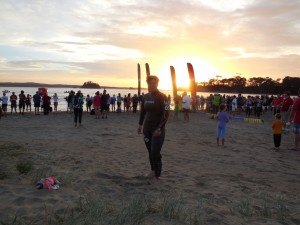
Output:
[196, 76, 300, 95]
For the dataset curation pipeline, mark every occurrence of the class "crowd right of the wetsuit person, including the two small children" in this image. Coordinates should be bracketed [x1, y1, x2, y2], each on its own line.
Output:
[168, 90, 300, 151]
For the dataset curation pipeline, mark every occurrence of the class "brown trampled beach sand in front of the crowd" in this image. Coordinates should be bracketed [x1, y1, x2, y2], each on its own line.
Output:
[0, 112, 300, 225]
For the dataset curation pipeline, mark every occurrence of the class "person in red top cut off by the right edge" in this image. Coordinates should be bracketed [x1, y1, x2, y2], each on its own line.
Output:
[290, 89, 300, 151]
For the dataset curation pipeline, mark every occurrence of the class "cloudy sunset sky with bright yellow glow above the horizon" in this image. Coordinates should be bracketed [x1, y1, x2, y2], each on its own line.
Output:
[0, 0, 300, 89]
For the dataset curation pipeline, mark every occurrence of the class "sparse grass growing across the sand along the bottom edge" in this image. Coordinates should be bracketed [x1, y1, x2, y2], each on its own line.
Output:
[0, 191, 293, 225]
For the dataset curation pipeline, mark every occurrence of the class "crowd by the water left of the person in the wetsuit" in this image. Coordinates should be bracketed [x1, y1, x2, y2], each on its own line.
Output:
[0, 90, 142, 118]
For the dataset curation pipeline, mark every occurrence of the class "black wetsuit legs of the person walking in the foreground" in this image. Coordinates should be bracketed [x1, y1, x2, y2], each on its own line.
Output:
[144, 129, 165, 177]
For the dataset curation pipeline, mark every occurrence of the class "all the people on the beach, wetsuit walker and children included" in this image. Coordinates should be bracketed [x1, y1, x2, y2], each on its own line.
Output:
[0, 85, 300, 181]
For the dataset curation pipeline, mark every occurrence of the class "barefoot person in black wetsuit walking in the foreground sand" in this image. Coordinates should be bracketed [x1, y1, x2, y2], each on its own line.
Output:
[138, 76, 170, 183]
